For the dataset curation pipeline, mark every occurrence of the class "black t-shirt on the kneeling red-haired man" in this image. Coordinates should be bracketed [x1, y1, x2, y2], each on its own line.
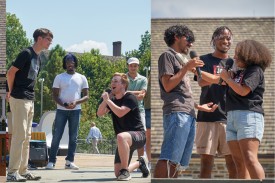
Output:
[109, 93, 144, 135]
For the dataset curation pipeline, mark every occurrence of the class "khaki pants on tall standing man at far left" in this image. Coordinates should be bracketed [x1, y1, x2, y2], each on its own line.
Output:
[8, 97, 34, 175]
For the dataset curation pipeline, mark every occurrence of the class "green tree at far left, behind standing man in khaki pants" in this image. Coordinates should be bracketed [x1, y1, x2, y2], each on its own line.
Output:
[6, 13, 31, 68]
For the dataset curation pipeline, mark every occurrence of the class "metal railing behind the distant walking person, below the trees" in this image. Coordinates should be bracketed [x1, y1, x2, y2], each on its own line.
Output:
[76, 139, 117, 154]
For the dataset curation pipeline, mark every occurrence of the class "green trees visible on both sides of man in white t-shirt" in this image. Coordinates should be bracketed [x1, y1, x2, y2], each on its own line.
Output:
[34, 45, 126, 139]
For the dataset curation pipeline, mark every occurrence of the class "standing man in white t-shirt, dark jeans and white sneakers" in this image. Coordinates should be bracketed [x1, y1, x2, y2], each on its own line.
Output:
[46, 53, 89, 170]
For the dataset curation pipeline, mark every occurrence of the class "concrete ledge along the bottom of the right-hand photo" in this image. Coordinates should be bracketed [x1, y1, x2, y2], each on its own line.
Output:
[151, 178, 274, 183]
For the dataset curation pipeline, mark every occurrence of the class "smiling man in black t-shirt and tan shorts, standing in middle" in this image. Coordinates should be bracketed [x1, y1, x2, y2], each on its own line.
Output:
[194, 26, 236, 178]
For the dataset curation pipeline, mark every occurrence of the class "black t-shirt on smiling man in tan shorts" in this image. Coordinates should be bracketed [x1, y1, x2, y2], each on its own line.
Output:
[194, 53, 233, 122]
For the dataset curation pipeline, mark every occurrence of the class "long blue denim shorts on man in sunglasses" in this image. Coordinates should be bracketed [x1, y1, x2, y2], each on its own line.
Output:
[159, 112, 196, 168]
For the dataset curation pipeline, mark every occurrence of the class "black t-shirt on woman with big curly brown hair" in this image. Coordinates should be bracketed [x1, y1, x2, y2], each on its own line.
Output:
[226, 65, 265, 114]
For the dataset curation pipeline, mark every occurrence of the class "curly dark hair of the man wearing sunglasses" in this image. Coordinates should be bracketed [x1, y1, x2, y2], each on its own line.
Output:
[164, 25, 195, 47]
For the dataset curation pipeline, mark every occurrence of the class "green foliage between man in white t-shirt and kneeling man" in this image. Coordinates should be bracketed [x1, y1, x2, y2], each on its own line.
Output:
[77, 49, 126, 139]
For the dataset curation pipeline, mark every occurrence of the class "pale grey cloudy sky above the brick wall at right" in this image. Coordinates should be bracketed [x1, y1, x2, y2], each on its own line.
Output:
[151, 0, 274, 18]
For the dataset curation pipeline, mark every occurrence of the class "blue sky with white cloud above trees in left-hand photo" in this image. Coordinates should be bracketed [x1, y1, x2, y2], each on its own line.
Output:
[6, 0, 151, 55]
